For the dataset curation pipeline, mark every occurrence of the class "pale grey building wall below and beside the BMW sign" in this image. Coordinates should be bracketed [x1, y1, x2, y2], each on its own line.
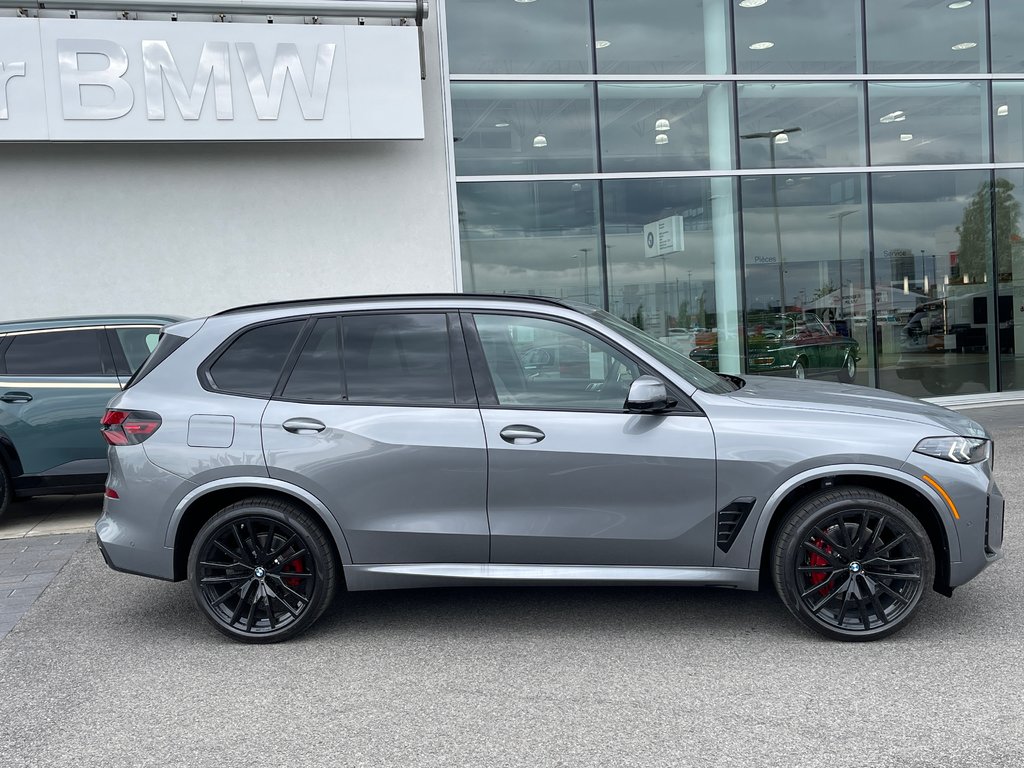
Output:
[0, 14, 456, 321]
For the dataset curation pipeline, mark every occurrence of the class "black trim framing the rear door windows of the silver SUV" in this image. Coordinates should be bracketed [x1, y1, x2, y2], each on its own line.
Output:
[270, 307, 478, 409]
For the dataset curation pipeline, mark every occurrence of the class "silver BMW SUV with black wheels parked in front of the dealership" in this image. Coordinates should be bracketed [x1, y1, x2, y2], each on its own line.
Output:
[96, 295, 1004, 643]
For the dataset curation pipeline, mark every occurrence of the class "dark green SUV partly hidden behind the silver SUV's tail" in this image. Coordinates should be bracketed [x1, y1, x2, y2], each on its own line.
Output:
[0, 316, 177, 516]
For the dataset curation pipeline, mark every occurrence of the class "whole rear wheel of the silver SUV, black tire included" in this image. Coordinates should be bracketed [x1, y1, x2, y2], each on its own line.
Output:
[188, 499, 338, 643]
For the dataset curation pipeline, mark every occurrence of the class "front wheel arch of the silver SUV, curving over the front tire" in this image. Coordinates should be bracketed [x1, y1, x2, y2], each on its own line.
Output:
[751, 467, 959, 596]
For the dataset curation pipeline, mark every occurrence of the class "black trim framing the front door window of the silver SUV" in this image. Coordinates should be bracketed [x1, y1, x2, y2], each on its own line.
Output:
[462, 308, 707, 418]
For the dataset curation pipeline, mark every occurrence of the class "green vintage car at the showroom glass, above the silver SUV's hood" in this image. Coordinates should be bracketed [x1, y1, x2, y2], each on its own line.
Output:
[690, 312, 860, 384]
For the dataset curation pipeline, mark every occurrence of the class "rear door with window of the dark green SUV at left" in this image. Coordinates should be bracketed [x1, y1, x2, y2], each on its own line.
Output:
[0, 327, 121, 475]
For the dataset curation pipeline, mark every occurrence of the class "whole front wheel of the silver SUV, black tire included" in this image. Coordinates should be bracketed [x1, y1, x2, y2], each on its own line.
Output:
[771, 486, 935, 641]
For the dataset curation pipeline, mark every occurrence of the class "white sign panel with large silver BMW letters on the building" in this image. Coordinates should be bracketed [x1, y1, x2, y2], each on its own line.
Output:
[0, 18, 423, 141]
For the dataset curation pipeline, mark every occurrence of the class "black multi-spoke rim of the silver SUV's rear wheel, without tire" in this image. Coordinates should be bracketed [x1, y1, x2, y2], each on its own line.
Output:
[197, 515, 317, 634]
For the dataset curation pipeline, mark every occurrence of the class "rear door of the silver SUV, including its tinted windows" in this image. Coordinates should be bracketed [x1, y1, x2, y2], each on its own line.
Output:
[262, 311, 488, 563]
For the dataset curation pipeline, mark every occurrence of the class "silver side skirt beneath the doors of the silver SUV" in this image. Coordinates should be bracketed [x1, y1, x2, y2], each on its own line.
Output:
[345, 563, 759, 592]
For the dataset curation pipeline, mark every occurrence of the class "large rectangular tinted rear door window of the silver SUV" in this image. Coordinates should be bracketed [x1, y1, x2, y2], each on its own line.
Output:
[342, 314, 455, 406]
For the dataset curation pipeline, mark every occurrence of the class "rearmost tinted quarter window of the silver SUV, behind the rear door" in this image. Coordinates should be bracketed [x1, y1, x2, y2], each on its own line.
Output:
[210, 319, 305, 397]
